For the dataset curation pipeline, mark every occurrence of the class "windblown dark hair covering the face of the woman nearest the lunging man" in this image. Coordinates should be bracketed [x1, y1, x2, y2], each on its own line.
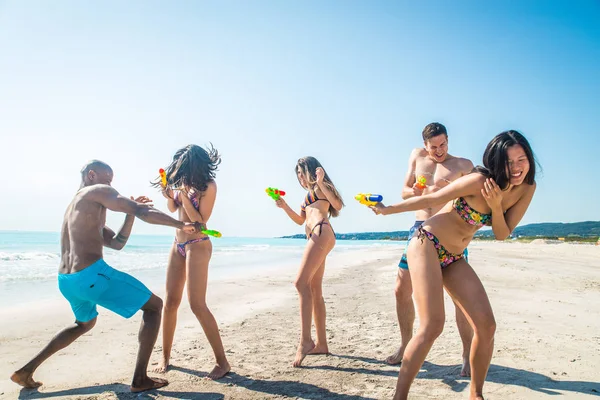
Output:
[151, 143, 221, 193]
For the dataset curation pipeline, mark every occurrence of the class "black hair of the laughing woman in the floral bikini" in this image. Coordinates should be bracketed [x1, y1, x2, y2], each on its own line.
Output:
[473, 130, 537, 190]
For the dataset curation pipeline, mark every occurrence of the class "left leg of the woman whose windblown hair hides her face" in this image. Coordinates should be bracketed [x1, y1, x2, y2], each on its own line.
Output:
[154, 245, 186, 373]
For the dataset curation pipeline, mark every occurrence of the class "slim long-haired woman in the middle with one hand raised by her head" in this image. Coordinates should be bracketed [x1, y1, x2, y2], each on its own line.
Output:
[276, 157, 344, 367]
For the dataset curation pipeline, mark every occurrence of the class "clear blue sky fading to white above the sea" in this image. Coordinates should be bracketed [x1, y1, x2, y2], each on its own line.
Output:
[0, 0, 600, 237]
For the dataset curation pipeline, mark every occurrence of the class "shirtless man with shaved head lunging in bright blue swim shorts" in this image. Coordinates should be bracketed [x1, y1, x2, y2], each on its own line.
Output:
[11, 160, 200, 392]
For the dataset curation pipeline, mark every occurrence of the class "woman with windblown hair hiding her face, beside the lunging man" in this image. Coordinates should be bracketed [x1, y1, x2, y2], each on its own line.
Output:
[153, 144, 230, 379]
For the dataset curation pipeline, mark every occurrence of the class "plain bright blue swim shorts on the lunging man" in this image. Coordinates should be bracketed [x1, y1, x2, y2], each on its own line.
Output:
[58, 259, 152, 322]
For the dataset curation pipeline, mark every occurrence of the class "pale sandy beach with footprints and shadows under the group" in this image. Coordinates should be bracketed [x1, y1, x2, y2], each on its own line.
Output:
[0, 242, 600, 400]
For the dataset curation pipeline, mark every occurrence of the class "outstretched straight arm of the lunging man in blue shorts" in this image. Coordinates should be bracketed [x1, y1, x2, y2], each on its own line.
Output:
[89, 185, 185, 229]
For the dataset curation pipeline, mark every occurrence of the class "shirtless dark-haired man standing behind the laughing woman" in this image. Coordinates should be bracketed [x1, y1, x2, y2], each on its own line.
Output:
[385, 122, 473, 376]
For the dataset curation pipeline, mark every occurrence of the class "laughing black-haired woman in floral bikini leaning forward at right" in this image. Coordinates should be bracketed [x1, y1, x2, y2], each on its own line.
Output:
[372, 130, 536, 400]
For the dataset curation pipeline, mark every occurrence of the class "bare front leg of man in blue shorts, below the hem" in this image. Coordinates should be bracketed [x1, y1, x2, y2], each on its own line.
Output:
[131, 294, 168, 392]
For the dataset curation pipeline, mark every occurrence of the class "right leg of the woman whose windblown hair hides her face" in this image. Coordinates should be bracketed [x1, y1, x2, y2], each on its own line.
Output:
[187, 240, 231, 379]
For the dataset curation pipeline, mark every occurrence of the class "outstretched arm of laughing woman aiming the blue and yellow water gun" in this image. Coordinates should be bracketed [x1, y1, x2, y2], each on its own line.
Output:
[378, 174, 485, 215]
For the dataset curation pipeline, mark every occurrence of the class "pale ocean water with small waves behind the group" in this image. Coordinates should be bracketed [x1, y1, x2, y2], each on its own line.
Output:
[0, 231, 398, 308]
